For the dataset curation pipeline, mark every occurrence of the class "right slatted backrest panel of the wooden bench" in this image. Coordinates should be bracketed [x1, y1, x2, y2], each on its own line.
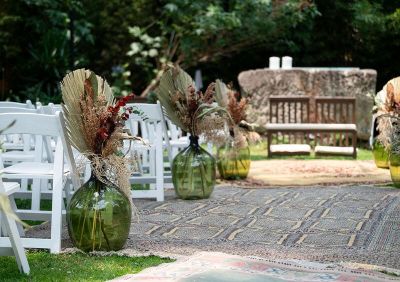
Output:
[315, 97, 356, 124]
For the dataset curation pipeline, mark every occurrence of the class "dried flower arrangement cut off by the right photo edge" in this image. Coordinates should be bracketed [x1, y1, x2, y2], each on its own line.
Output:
[374, 77, 400, 153]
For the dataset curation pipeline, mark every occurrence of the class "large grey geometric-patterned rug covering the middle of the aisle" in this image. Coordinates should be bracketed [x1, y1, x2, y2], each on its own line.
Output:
[126, 185, 400, 269]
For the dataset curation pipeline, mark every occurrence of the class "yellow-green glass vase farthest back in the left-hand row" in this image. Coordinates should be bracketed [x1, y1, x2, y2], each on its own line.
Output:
[217, 142, 251, 180]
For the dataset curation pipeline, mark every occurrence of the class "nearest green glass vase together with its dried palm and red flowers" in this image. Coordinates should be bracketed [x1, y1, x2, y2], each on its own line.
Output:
[61, 69, 138, 251]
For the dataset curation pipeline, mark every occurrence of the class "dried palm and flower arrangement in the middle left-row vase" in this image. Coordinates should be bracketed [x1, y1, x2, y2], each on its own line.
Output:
[156, 66, 227, 143]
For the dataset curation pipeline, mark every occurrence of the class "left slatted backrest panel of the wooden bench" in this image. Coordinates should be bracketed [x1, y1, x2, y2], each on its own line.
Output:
[269, 96, 310, 123]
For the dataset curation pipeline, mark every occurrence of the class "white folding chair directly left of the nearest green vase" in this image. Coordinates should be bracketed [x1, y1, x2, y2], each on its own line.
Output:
[0, 113, 80, 253]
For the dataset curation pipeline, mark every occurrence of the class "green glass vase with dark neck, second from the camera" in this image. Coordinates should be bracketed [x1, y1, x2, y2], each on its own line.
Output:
[172, 136, 216, 200]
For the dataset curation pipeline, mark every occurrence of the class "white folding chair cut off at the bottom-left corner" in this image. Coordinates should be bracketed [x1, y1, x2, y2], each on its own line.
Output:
[0, 178, 30, 274]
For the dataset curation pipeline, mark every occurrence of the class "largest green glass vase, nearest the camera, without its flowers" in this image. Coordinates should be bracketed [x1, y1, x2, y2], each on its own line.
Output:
[67, 175, 132, 252]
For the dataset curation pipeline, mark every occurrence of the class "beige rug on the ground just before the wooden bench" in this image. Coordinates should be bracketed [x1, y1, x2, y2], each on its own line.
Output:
[241, 160, 391, 187]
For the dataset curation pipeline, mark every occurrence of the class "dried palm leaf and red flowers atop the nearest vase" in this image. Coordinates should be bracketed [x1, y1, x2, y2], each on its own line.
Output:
[61, 69, 134, 198]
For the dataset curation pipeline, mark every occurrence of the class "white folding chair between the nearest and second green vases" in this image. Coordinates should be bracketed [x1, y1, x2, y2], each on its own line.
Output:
[127, 104, 164, 201]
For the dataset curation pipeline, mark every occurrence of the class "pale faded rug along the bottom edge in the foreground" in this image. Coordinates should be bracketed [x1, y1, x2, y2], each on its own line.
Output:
[113, 252, 395, 282]
